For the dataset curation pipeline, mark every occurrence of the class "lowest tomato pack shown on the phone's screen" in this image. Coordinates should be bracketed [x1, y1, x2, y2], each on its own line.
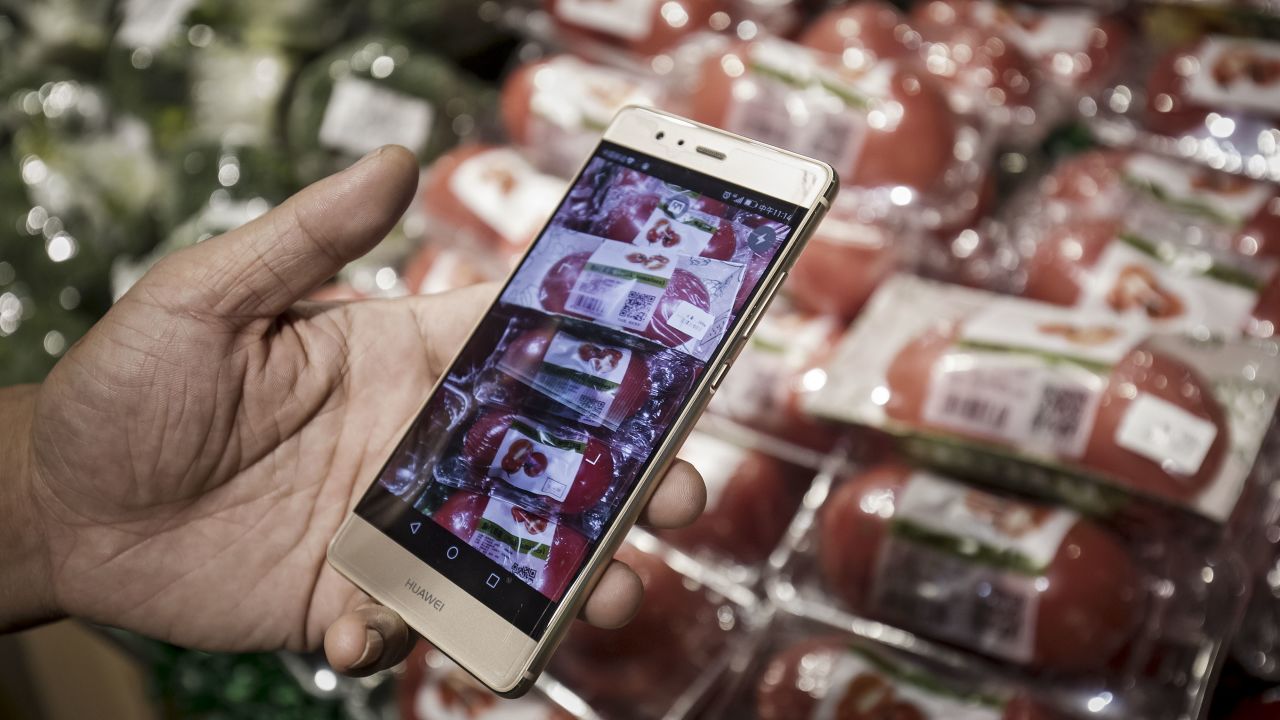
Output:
[431, 489, 588, 600]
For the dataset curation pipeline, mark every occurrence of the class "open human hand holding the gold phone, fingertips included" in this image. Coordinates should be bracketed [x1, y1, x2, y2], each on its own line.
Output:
[10, 147, 705, 674]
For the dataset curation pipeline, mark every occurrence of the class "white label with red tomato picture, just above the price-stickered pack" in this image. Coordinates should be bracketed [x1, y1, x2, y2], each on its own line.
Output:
[1076, 234, 1258, 333]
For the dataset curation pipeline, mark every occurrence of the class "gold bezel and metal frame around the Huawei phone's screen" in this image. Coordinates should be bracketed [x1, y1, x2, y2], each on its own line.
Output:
[328, 108, 837, 697]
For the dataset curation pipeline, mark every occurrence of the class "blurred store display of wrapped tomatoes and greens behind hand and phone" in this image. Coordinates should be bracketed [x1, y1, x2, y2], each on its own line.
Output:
[0, 0, 1280, 720]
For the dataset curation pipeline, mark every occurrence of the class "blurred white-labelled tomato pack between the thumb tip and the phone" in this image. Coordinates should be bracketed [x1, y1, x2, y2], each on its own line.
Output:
[419, 145, 564, 263]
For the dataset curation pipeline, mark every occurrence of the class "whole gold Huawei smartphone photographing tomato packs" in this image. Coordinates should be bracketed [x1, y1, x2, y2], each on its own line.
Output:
[329, 108, 836, 697]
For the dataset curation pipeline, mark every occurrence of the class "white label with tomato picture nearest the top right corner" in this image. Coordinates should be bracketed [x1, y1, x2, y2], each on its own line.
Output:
[1187, 36, 1280, 114]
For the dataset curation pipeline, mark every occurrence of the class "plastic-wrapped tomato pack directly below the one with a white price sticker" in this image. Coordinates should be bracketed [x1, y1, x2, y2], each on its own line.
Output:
[758, 460, 1248, 720]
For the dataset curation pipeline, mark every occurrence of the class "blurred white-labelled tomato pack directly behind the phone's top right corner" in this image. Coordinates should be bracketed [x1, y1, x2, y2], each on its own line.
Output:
[690, 37, 984, 224]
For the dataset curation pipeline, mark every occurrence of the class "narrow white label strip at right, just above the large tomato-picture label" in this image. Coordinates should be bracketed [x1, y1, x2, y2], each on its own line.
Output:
[1124, 152, 1276, 228]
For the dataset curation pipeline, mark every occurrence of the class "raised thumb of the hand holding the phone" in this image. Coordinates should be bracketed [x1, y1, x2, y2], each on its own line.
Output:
[138, 145, 417, 327]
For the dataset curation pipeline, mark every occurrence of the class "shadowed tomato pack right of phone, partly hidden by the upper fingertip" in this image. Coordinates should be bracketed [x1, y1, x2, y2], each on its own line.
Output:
[657, 430, 813, 565]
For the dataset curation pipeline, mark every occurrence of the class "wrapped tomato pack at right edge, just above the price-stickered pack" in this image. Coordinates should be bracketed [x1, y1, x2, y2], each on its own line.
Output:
[1006, 151, 1280, 338]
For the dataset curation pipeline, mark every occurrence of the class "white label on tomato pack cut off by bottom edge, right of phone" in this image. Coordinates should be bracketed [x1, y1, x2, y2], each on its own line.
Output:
[814, 652, 1005, 720]
